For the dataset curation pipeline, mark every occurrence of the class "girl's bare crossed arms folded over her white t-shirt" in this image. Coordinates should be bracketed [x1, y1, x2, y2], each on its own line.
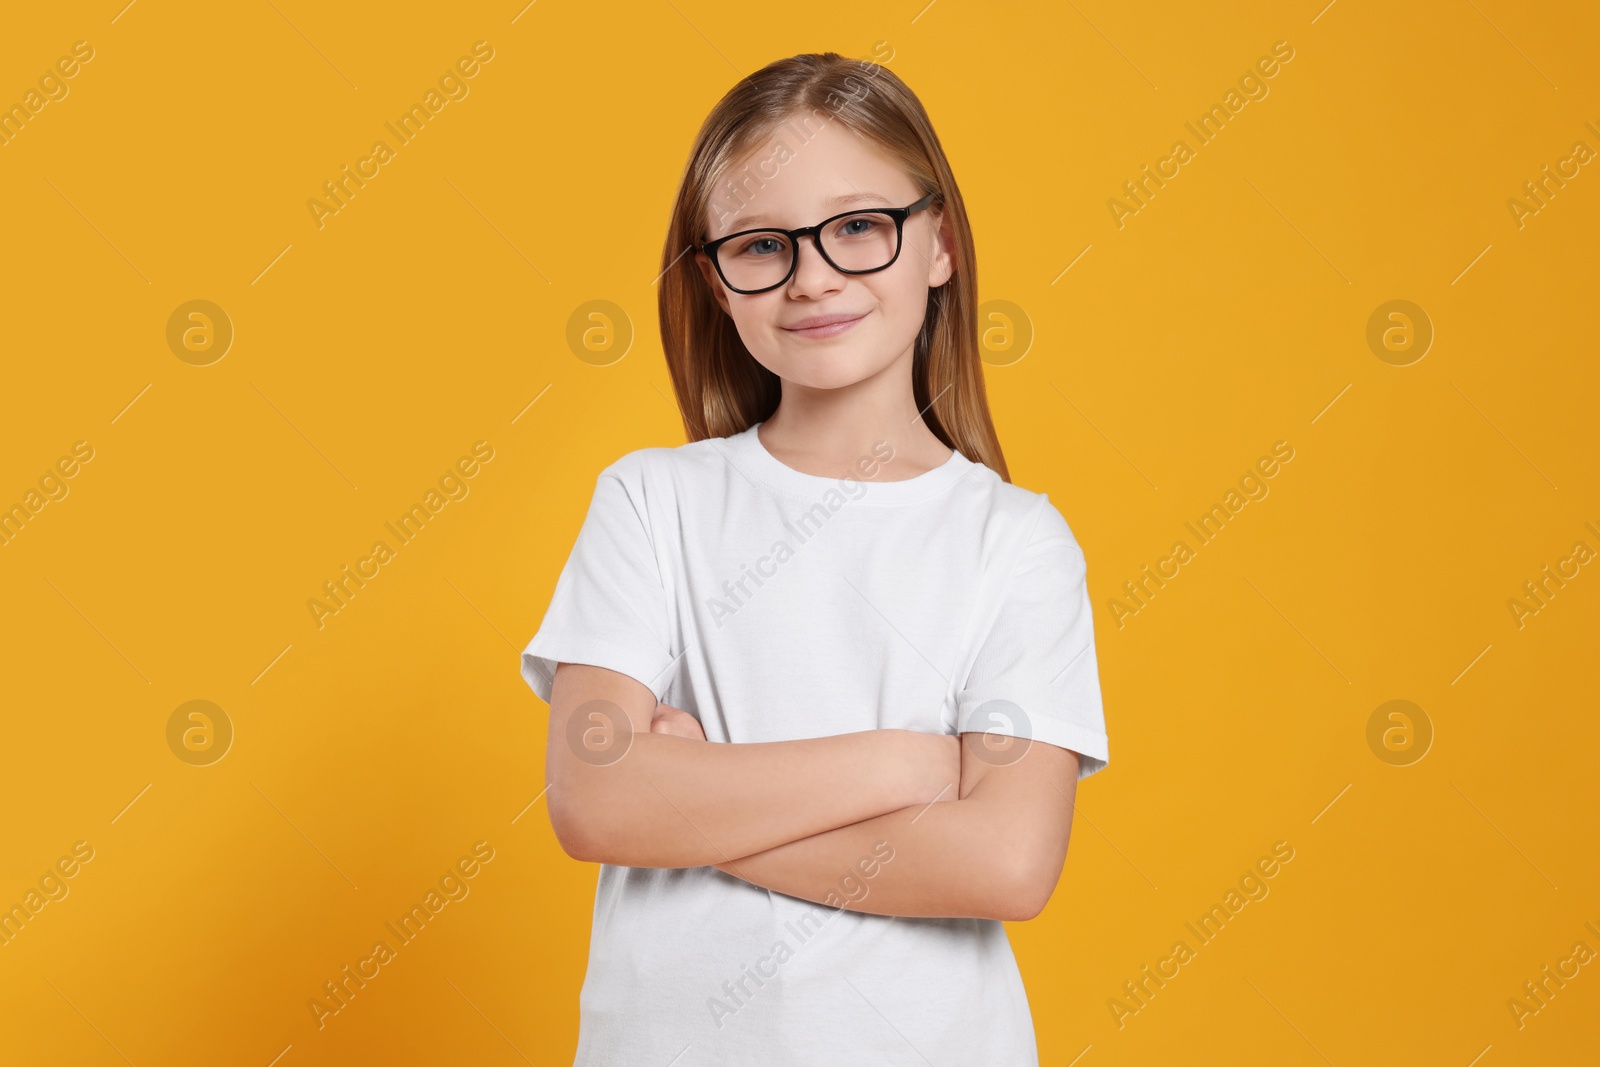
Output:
[546, 664, 1078, 921]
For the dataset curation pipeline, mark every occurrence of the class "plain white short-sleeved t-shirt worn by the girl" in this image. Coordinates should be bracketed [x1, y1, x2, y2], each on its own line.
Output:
[522, 424, 1107, 1067]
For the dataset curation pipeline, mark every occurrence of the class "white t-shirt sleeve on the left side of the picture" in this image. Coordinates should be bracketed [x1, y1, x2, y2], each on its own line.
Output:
[522, 453, 675, 704]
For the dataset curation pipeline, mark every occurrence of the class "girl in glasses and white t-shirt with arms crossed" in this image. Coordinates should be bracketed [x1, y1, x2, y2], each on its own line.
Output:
[522, 53, 1107, 1067]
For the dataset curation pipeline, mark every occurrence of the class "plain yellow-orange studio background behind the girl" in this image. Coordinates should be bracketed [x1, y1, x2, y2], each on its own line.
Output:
[0, 0, 1600, 1067]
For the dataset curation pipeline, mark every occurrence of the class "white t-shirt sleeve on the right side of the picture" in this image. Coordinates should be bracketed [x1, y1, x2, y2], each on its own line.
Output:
[957, 498, 1110, 779]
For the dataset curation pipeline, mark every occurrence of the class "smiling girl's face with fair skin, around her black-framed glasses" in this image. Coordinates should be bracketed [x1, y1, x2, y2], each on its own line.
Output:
[694, 118, 954, 389]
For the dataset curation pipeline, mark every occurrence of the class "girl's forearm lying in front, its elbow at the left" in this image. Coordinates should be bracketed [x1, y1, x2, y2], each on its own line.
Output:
[547, 729, 960, 867]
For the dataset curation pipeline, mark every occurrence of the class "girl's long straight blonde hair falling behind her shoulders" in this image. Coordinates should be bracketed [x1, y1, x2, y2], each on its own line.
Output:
[658, 51, 1011, 482]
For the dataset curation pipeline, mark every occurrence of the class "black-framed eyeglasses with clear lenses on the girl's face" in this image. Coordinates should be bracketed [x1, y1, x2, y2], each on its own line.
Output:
[699, 192, 939, 296]
